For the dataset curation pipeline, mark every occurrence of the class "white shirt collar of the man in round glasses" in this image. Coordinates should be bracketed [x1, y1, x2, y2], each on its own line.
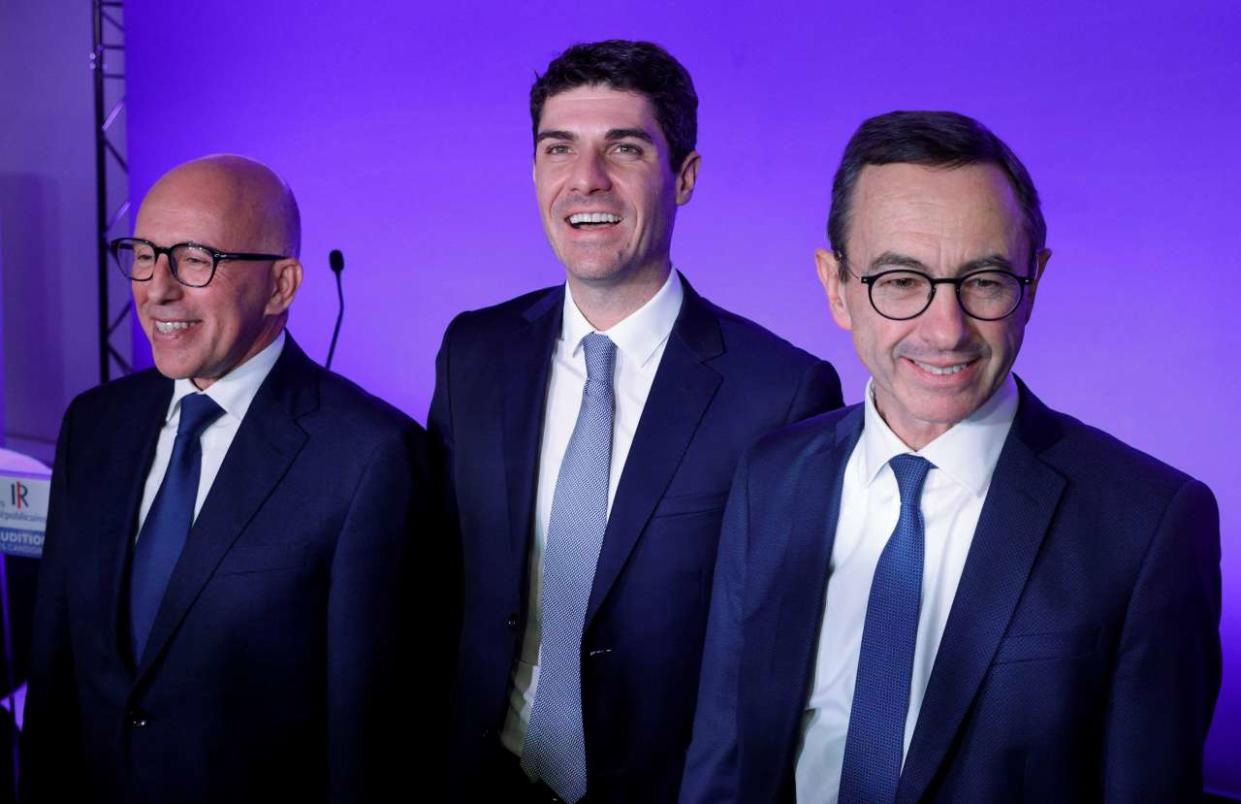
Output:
[861, 373, 1019, 496]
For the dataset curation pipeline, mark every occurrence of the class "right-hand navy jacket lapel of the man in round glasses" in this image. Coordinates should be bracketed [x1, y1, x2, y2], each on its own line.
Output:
[896, 381, 1065, 802]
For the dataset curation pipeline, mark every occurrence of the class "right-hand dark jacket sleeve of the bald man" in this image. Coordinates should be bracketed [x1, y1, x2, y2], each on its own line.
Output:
[326, 422, 431, 803]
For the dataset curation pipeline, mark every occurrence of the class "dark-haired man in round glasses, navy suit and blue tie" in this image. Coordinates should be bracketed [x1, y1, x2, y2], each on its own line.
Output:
[683, 113, 1220, 803]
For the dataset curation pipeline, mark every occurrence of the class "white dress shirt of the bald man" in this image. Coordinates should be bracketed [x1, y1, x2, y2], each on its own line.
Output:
[134, 330, 284, 541]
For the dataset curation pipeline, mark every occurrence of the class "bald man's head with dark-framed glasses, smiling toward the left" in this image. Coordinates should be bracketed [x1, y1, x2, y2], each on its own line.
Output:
[133, 155, 302, 388]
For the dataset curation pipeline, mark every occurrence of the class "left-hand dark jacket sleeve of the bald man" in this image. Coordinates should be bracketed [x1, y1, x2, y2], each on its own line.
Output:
[20, 406, 88, 803]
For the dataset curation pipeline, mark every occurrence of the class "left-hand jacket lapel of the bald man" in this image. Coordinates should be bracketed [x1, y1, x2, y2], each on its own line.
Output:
[96, 371, 172, 665]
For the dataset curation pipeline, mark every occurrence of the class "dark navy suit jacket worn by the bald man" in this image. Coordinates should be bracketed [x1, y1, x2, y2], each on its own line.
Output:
[21, 339, 426, 804]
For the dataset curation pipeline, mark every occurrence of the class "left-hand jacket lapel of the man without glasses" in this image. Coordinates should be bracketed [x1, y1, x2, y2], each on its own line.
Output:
[500, 287, 565, 565]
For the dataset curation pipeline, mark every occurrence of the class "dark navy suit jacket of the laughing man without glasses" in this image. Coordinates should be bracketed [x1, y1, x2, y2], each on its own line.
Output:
[428, 274, 840, 803]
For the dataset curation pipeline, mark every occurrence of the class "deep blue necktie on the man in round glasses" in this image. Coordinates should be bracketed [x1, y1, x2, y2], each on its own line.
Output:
[840, 455, 932, 804]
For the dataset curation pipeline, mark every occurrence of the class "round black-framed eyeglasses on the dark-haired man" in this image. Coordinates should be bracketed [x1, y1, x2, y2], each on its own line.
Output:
[838, 254, 1034, 321]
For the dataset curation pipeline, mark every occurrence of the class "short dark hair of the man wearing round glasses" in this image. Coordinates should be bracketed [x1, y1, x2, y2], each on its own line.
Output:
[828, 112, 1047, 278]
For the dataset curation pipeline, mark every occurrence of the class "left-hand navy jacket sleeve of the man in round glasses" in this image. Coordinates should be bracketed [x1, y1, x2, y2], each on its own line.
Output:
[679, 453, 750, 804]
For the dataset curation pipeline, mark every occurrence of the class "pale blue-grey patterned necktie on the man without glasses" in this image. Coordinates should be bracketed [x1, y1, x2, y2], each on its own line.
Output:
[521, 333, 616, 803]
